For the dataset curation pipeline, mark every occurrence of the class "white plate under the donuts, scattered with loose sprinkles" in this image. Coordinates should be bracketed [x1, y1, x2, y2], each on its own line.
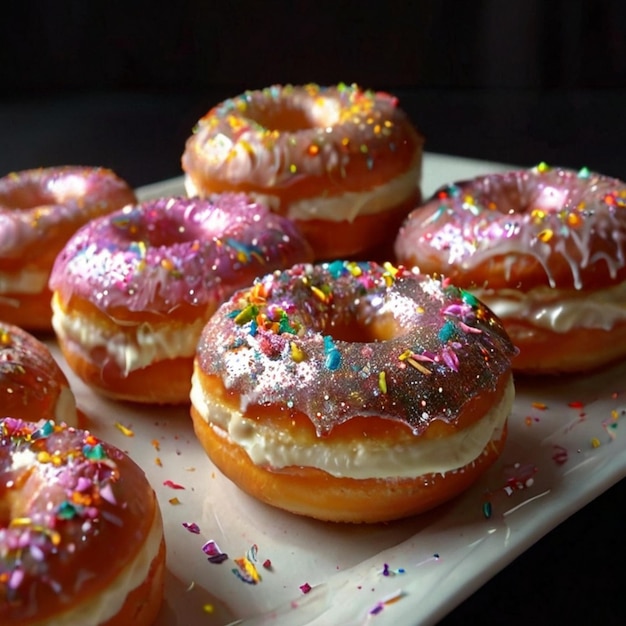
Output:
[51, 154, 626, 626]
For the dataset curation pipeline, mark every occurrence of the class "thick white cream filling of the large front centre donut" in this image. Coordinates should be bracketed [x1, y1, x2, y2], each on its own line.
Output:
[191, 373, 515, 479]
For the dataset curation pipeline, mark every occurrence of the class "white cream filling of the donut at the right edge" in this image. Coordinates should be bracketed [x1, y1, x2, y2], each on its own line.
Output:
[472, 283, 626, 333]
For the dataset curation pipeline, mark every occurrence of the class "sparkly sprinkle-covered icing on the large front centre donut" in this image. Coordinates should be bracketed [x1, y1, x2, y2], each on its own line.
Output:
[197, 261, 515, 434]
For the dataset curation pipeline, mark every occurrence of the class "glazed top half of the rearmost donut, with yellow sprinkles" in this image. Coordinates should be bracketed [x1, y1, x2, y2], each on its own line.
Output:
[182, 84, 423, 207]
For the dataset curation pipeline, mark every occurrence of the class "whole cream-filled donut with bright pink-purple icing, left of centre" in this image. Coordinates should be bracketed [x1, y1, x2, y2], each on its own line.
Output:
[50, 194, 312, 404]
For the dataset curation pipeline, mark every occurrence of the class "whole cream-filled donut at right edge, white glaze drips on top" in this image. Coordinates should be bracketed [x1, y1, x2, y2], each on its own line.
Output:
[395, 164, 626, 374]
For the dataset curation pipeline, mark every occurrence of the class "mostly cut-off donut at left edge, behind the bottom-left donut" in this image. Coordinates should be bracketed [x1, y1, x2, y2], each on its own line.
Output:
[0, 322, 78, 426]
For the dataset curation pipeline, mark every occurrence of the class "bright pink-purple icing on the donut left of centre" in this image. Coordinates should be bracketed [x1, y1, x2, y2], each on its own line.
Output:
[50, 194, 312, 313]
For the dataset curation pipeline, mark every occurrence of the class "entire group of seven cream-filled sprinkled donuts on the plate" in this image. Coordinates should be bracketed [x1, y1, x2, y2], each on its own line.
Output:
[0, 84, 626, 624]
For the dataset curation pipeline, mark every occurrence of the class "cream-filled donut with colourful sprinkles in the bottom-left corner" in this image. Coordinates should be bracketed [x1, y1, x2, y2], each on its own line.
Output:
[0, 417, 165, 626]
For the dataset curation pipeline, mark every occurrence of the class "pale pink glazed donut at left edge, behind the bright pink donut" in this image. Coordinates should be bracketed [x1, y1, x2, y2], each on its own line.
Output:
[0, 166, 135, 331]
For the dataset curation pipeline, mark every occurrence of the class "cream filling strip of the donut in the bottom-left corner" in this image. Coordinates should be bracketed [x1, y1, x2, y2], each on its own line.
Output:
[40, 508, 163, 626]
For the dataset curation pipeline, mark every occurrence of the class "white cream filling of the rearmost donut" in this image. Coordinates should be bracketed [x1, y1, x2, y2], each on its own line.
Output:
[185, 156, 422, 222]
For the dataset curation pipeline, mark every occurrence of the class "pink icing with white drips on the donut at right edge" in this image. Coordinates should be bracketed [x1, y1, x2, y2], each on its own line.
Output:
[395, 164, 626, 289]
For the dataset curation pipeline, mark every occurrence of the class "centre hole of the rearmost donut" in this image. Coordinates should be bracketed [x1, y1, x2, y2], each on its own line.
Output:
[248, 98, 339, 133]
